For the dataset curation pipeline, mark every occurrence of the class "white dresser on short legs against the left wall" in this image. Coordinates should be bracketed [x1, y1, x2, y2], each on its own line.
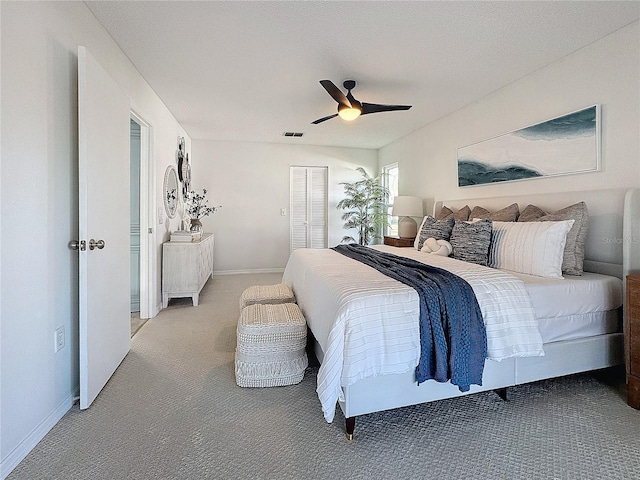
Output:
[162, 233, 213, 308]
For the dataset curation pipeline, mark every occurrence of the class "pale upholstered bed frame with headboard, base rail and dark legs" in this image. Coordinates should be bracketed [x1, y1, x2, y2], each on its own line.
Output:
[315, 189, 640, 439]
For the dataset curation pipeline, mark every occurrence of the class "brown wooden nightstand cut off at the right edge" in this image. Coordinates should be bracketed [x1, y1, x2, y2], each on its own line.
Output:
[624, 275, 640, 409]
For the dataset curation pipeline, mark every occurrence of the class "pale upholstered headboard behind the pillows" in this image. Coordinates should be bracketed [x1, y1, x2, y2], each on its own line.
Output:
[434, 189, 640, 278]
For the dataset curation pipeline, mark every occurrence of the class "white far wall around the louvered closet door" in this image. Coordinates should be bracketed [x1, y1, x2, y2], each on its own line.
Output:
[192, 139, 377, 272]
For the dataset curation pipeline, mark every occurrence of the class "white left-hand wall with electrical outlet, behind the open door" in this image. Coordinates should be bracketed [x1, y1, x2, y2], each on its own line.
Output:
[0, 2, 190, 478]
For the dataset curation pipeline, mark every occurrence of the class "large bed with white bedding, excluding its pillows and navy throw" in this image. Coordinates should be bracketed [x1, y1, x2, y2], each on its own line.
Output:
[283, 190, 640, 438]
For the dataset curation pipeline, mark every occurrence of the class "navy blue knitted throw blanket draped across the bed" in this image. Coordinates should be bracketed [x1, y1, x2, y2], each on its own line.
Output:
[333, 244, 487, 392]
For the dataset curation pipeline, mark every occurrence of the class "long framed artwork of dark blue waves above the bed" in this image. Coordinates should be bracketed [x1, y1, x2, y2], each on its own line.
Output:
[458, 105, 600, 187]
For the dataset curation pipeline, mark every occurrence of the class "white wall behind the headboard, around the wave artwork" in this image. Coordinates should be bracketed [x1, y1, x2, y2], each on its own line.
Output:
[379, 22, 640, 212]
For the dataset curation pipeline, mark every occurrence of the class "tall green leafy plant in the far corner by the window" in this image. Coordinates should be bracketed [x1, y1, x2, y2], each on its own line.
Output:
[336, 167, 389, 245]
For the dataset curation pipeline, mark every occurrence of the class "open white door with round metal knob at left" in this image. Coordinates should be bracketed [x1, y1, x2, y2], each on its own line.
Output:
[78, 47, 131, 409]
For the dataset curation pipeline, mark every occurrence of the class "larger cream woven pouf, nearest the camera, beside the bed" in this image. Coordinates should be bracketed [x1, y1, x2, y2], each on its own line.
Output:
[235, 303, 308, 387]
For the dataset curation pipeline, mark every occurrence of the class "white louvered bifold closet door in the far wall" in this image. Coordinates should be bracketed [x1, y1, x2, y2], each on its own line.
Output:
[289, 167, 328, 250]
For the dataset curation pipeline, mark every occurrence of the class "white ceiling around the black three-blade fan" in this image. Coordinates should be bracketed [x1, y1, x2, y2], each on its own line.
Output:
[86, 1, 640, 149]
